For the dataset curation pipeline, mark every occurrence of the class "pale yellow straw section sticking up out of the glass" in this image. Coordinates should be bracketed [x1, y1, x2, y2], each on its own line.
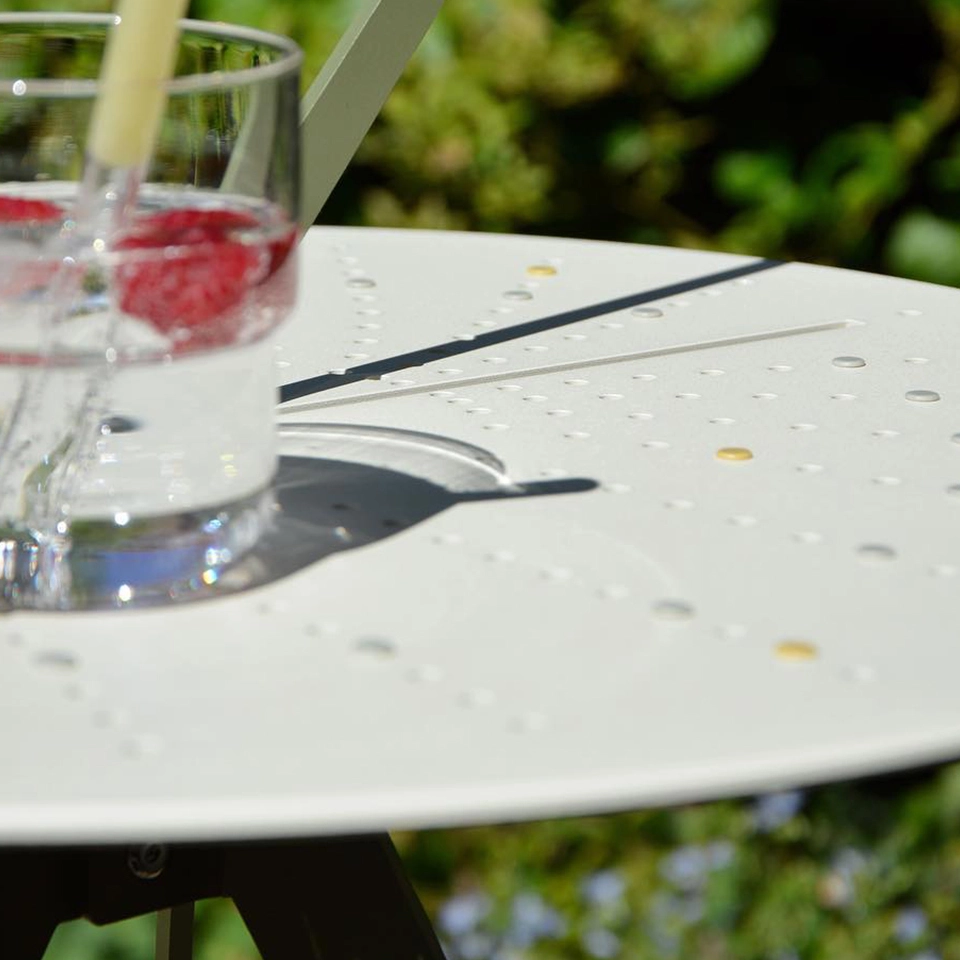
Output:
[88, 0, 188, 168]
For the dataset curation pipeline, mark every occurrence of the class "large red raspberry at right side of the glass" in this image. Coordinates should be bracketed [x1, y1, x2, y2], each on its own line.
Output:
[116, 209, 272, 349]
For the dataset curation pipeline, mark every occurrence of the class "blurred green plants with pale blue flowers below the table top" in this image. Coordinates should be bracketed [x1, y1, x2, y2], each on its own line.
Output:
[47, 765, 960, 960]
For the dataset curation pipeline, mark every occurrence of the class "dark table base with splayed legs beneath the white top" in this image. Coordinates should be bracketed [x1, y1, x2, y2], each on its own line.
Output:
[0, 835, 443, 960]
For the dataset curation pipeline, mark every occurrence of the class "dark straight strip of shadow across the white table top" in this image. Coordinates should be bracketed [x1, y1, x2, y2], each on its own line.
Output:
[280, 260, 784, 403]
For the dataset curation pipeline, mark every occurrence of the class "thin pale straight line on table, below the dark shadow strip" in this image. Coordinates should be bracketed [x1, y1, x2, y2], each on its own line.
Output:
[281, 320, 863, 413]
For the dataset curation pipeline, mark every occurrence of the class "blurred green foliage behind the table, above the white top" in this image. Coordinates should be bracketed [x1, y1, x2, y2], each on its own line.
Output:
[11, 0, 960, 284]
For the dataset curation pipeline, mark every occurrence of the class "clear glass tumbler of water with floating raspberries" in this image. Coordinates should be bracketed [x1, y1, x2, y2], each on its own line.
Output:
[0, 14, 301, 609]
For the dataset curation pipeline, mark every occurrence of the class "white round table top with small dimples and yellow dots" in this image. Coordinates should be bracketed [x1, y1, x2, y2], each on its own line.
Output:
[0, 228, 960, 844]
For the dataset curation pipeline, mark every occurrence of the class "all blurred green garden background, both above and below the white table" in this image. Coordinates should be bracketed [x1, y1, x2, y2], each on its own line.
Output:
[9, 0, 960, 960]
